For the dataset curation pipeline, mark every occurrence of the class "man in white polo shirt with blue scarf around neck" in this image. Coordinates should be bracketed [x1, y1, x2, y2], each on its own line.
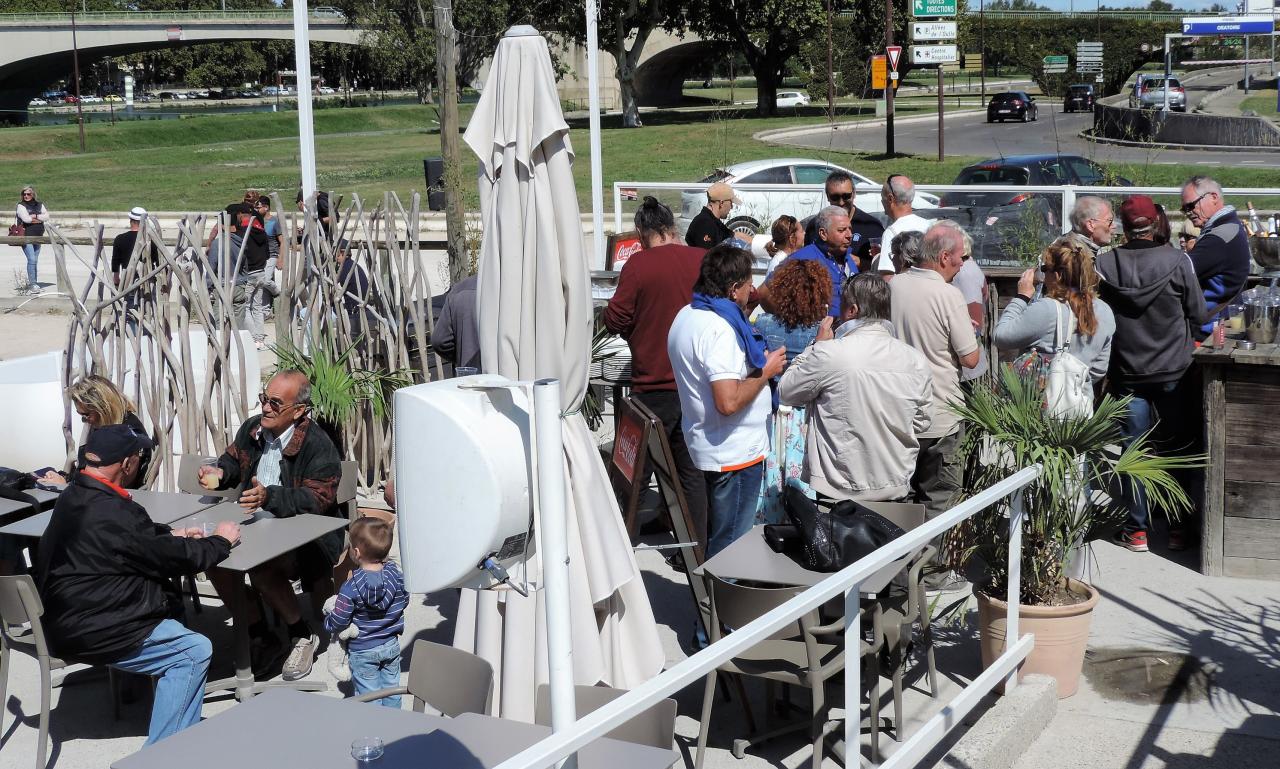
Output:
[667, 244, 786, 558]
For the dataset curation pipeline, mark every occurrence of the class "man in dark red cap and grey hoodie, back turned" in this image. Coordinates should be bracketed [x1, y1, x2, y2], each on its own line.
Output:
[1097, 194, 1204, 553]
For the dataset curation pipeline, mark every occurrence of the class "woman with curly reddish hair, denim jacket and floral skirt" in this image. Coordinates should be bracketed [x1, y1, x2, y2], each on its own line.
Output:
[755, 260, 831, 523]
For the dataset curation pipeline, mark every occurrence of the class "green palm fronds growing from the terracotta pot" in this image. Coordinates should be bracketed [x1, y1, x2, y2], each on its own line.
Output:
[945, 366, 1203, 605]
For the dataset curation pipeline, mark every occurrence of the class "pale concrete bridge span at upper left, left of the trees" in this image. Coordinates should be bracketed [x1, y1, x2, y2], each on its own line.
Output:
[0, 8, 362, 123]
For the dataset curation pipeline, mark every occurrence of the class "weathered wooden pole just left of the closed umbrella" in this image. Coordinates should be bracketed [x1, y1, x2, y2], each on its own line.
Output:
[435, 0, 471, 285]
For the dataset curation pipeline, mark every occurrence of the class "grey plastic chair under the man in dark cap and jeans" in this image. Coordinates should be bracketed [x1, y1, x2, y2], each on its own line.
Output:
[0, 575, 128, 769]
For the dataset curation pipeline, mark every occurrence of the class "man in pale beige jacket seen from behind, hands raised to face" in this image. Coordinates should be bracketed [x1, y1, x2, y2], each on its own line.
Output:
[778, 273, 933, 502]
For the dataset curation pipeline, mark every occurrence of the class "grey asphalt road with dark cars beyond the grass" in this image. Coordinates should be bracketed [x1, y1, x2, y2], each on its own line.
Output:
[786, 72, 1280, 168]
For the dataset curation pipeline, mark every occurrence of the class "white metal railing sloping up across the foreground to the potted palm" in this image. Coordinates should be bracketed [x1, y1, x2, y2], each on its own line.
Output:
[486, 464, 1041, 769]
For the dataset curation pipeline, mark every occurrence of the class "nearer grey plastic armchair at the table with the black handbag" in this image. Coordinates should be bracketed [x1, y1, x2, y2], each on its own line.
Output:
[694, 575, 883, 769]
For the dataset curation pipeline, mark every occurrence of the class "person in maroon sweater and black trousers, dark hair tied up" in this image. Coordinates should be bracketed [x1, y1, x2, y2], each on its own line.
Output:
[604, 197, 707, 549]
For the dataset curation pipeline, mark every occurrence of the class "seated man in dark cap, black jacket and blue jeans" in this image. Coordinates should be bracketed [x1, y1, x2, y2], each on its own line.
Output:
[36, 425, 239, 745]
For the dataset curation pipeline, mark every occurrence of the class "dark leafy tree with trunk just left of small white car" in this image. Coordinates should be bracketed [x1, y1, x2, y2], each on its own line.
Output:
[686, 0, 827, 115]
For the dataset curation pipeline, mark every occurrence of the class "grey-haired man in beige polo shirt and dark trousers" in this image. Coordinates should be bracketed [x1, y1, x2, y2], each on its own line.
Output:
[890, 223, 978, 518]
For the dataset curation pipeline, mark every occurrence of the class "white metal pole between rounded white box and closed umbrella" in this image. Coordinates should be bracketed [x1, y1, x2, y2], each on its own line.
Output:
[534, 379, 577, 769]
